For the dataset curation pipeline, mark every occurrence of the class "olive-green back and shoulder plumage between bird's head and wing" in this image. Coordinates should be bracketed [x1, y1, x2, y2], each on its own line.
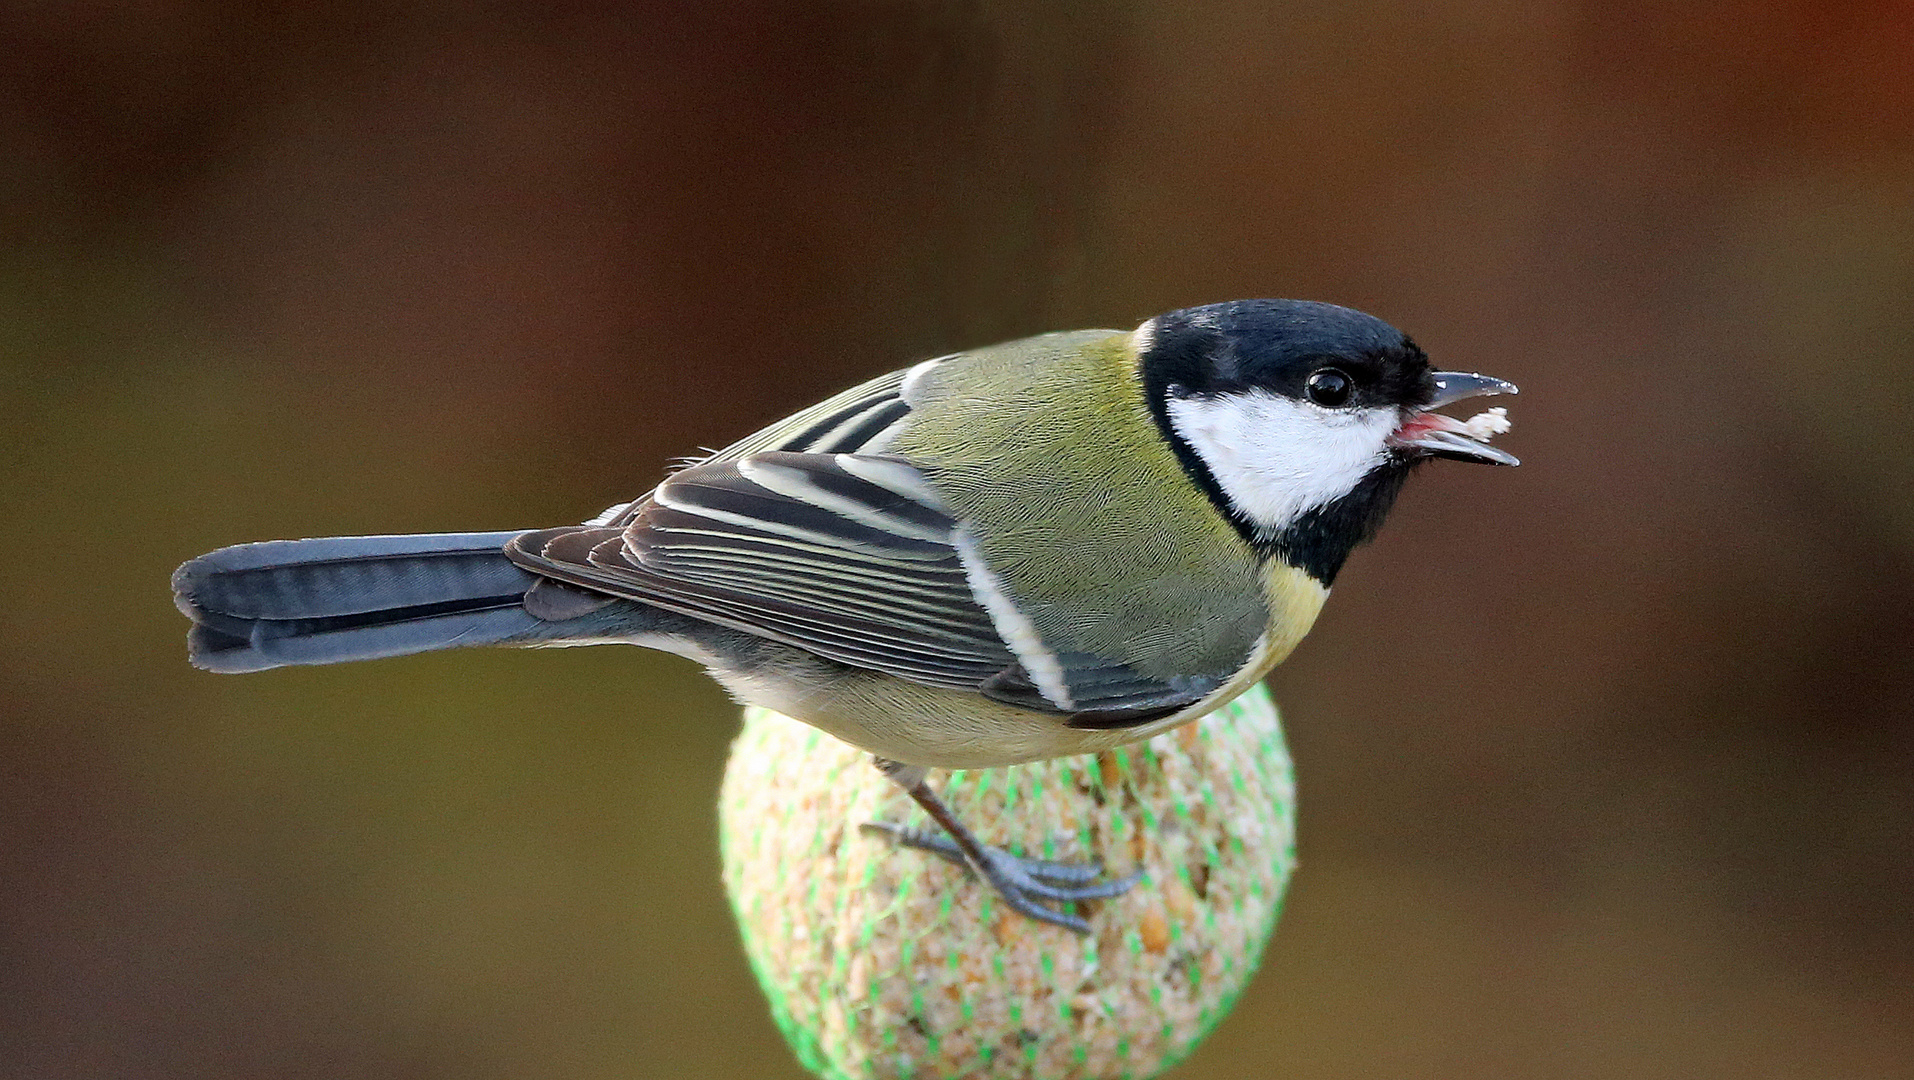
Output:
[890, 329, 1269, 678]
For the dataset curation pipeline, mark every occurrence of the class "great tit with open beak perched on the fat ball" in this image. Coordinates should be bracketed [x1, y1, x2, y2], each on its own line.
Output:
[172, 301, 1516, 931]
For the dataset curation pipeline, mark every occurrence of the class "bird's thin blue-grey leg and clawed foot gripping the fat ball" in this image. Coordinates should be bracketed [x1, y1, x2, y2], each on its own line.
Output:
[865, 758, 1141, 934]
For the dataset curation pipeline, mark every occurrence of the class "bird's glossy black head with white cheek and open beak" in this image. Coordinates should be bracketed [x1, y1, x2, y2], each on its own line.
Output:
[1135, 301, 1514, 584]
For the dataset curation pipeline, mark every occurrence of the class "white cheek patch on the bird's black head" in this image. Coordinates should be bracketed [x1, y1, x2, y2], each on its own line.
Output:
[1168, 391, 1401, 532]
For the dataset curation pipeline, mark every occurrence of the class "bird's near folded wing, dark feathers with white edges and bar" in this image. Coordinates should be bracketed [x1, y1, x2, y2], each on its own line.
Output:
[505, 452, 1210, 726]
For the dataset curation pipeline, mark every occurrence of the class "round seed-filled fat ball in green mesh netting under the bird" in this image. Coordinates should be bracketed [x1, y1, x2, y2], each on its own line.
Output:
[720, 686, 1294, 1080]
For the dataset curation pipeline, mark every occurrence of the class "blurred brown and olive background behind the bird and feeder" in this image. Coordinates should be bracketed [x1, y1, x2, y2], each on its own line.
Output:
[0, 0, 1914, 1080]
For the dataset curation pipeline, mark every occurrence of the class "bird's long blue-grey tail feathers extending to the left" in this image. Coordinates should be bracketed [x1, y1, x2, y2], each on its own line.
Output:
[172, 530, 547, 672]
